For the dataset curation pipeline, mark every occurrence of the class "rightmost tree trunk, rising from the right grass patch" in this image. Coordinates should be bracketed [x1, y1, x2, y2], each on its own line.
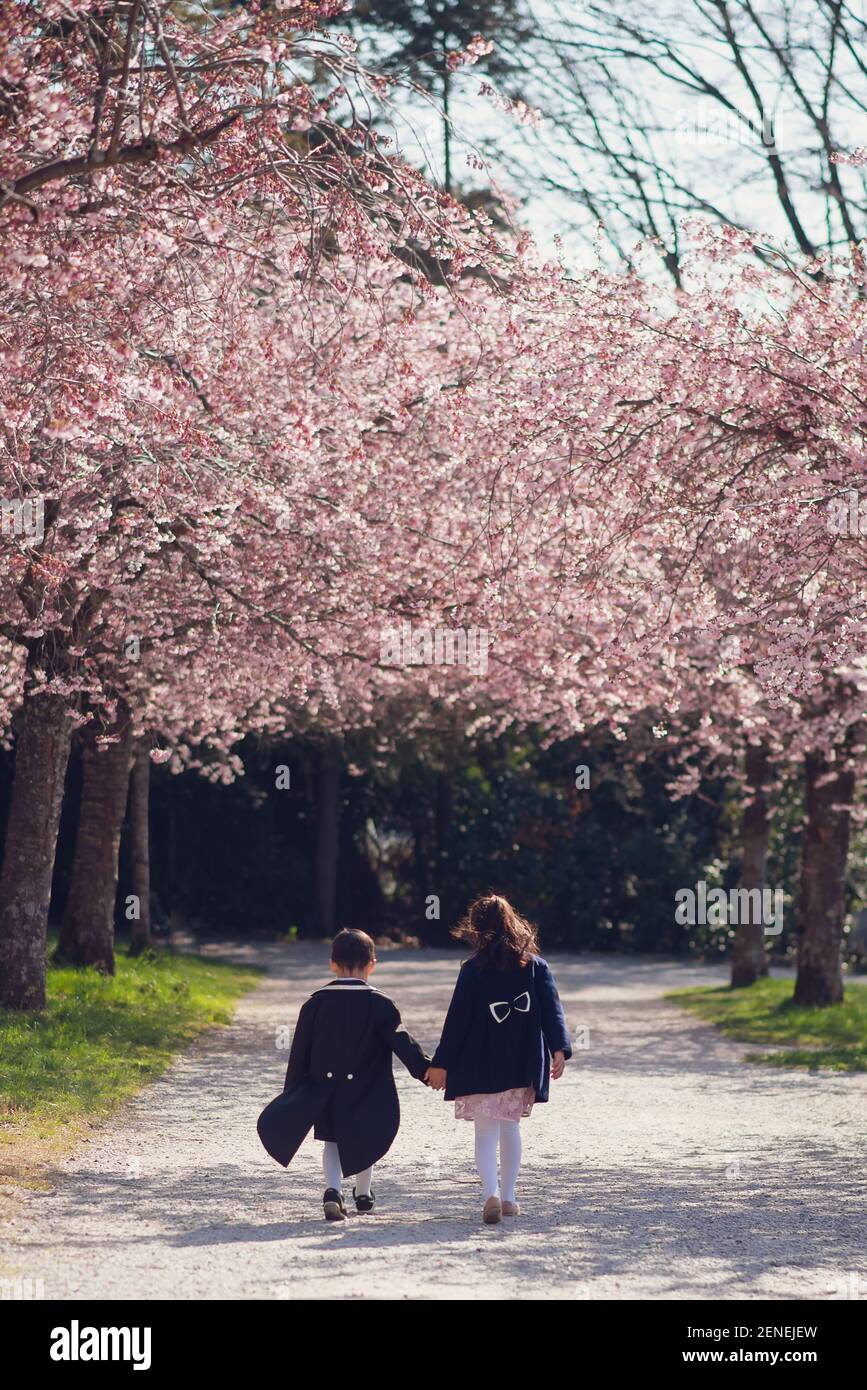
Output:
[795, 752, 854, 1008]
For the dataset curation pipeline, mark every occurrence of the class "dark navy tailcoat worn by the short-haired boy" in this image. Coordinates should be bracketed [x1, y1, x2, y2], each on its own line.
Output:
[257, 980, 431, 1176]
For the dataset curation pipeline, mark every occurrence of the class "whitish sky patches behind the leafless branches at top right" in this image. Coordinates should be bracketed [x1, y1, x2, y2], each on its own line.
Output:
[348, 0, 867, 263]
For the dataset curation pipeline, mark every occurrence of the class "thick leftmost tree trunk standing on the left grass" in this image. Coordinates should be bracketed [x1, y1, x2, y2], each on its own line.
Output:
[0, 694, 72, 1009]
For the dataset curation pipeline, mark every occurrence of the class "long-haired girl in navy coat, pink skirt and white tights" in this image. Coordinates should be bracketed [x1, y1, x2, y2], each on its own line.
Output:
[428, 894, 572, 1225]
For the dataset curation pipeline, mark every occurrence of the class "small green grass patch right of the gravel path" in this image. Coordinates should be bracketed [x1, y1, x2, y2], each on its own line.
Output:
[667, 979, 867, 1072]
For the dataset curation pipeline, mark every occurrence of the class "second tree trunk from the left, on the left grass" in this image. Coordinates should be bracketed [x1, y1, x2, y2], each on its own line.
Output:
[57, 705, 131, 974]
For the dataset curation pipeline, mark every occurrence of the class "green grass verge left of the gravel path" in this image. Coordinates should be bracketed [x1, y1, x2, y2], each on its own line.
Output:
[0, 949, 258, 1186]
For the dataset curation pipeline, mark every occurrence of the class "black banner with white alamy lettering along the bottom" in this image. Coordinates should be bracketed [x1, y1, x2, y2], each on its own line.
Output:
[0, 1290, 863, 1384]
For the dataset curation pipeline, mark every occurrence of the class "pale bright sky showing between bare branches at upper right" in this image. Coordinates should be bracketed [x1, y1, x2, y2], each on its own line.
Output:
[348, 0, 867, 265]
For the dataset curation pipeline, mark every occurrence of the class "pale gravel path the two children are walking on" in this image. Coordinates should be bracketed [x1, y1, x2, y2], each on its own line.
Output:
[0, 944, 867, 1298]
